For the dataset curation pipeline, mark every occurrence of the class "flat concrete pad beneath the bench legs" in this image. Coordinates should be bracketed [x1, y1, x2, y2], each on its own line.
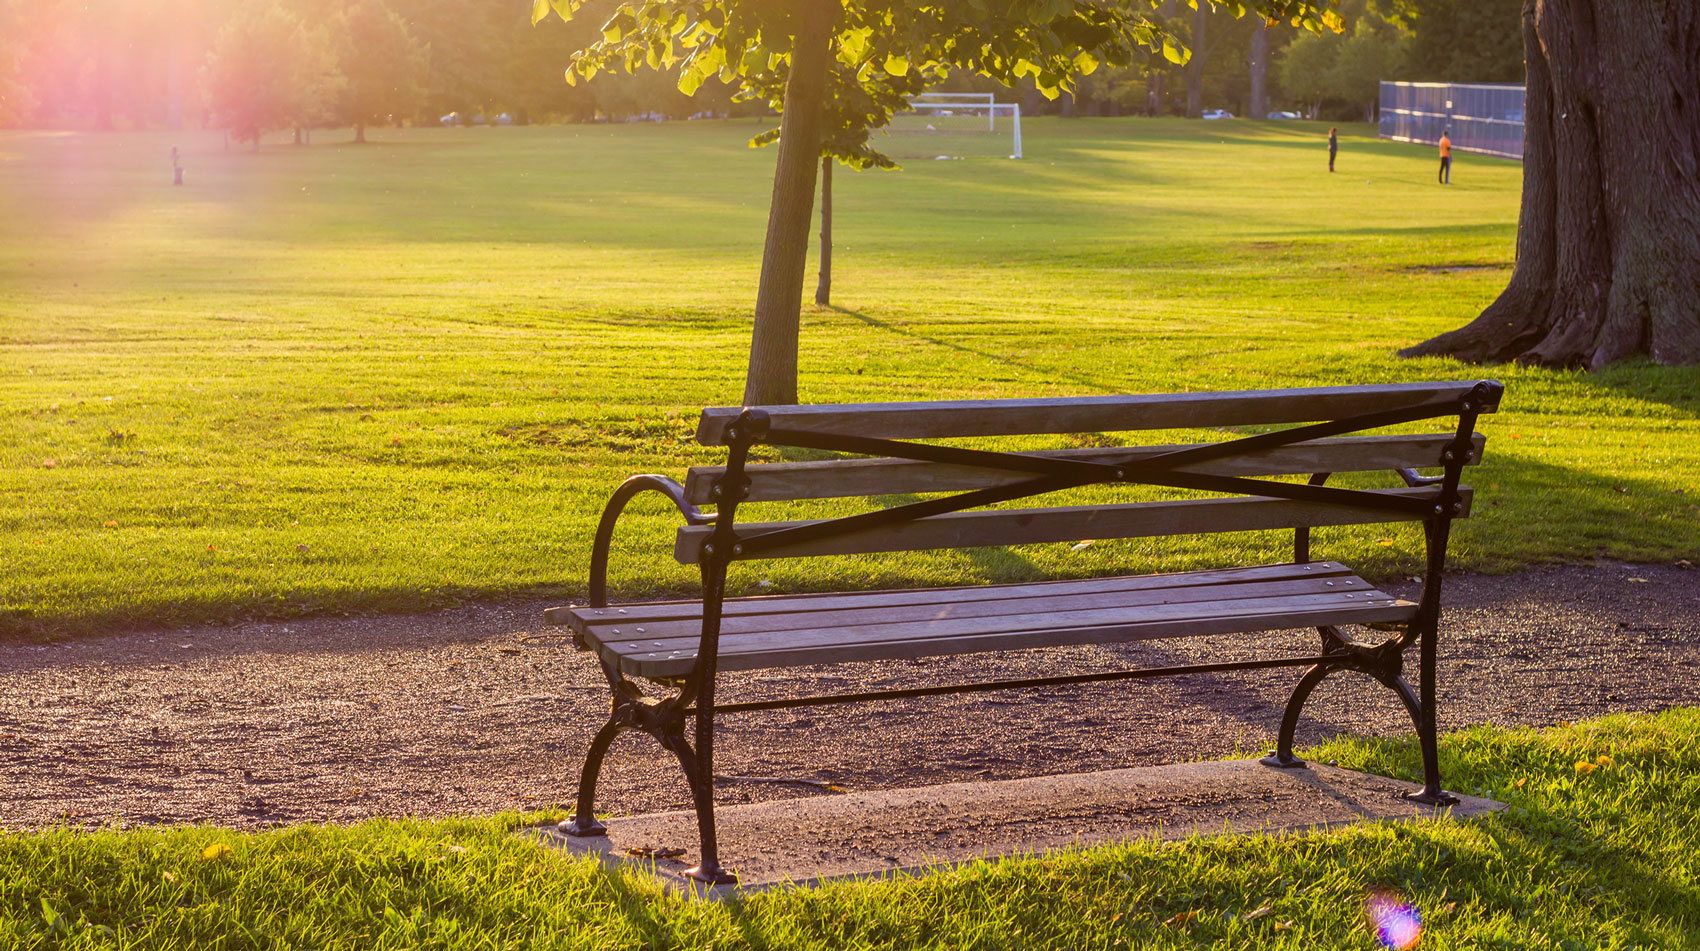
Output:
[522, 759, 1506, 890]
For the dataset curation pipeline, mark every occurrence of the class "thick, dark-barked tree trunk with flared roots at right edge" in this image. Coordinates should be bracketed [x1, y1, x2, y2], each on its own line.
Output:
[1403, 0, 1700, 369]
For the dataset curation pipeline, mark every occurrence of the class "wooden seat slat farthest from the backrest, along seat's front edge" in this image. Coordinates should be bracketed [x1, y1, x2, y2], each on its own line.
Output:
[544, 561, 1353, 633]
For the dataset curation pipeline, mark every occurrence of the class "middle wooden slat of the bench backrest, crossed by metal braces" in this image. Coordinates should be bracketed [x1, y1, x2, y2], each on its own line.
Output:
[685, 432, 1486, 505]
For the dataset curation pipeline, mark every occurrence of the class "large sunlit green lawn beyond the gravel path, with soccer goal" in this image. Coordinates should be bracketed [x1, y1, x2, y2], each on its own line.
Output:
[0, 119, 1700, 636]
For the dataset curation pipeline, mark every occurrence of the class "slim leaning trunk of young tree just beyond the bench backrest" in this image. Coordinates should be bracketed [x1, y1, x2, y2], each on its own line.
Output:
[745, 0, 836, 405]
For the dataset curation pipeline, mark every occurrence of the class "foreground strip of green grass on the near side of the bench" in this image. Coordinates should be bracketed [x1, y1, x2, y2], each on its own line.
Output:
[0, 711, 1700, 951]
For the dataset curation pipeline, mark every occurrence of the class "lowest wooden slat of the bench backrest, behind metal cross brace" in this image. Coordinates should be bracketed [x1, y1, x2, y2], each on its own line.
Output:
[673, 487, 1471, 565]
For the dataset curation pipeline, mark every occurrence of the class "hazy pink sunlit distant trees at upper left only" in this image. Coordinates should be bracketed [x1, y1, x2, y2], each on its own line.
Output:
[0, 0, 736, 140]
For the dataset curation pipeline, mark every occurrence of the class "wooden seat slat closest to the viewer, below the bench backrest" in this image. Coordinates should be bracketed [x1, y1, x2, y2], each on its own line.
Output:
[604, 594, 1416, 677]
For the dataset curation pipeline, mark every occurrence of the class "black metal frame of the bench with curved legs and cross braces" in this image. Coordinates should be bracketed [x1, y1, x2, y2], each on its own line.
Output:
[561, 381, 1503, 885]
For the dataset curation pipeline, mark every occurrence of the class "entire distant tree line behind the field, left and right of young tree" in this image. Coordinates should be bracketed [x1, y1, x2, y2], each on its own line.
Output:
[0, 0, 1523, 141]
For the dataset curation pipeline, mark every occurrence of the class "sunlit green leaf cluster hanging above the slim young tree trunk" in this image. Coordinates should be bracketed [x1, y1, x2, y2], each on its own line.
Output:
[532, 0, 1340, 167]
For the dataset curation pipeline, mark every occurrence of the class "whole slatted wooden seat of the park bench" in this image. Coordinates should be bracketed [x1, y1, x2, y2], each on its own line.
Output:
[549, 561, 1416, 679]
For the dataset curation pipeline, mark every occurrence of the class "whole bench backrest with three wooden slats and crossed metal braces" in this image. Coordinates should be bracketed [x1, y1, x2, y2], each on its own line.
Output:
[675, 381, 1503, 563]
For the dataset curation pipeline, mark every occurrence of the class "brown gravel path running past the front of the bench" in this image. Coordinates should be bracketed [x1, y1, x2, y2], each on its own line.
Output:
[0, 563, 1700, 829]
